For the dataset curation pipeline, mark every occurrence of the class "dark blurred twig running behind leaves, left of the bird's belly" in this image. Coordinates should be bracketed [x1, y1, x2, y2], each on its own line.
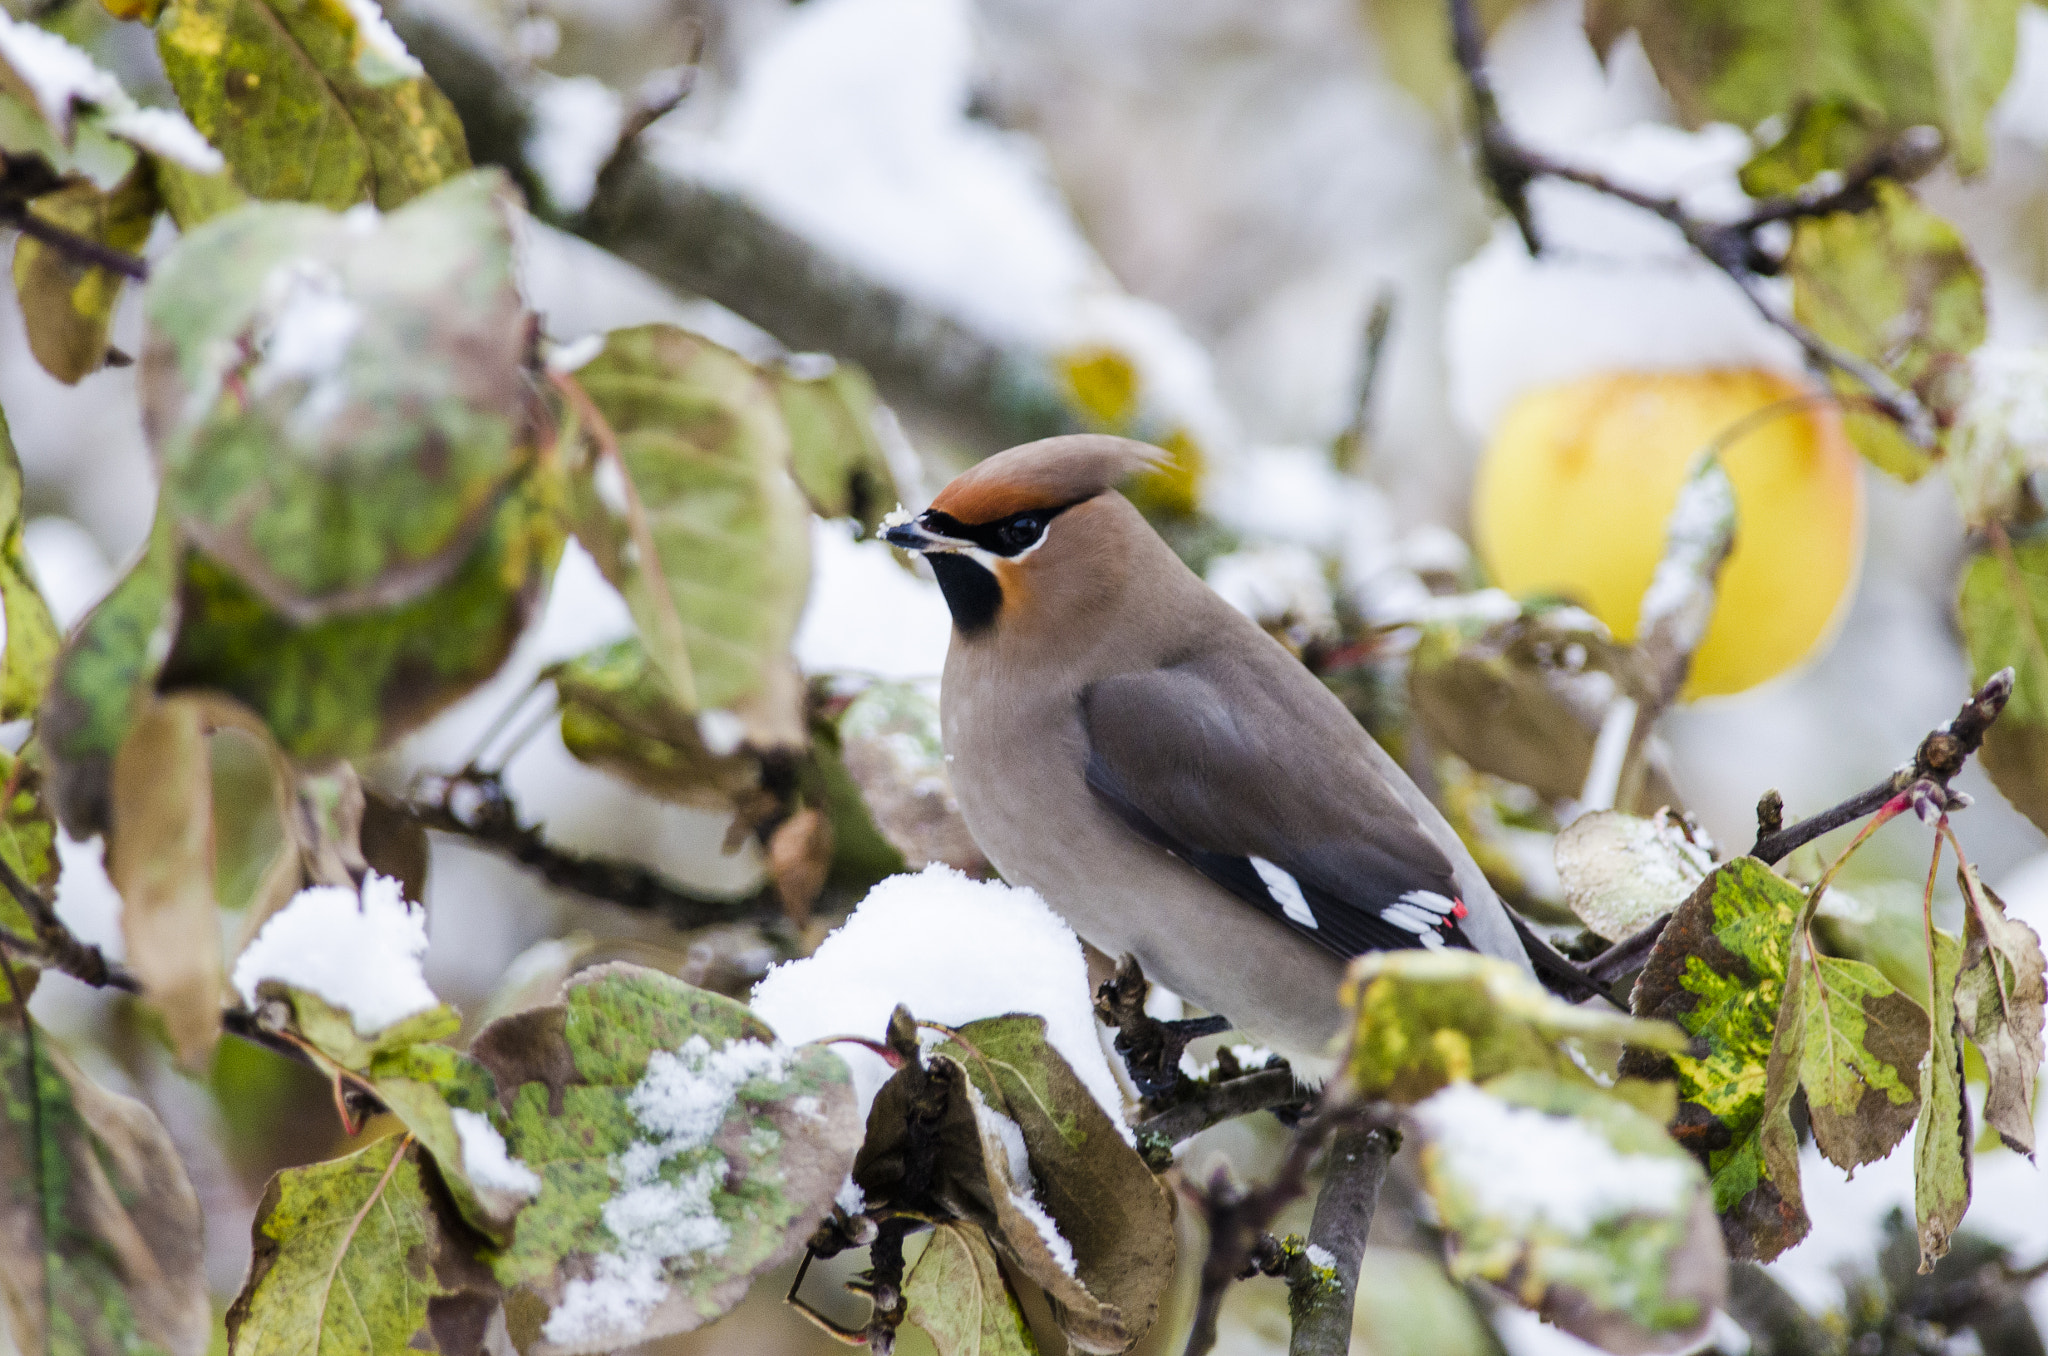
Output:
[391, 772, 782, 928]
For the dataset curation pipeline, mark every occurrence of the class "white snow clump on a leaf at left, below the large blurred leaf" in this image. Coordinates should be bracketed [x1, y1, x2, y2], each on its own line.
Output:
[233, 871, 440, 1036]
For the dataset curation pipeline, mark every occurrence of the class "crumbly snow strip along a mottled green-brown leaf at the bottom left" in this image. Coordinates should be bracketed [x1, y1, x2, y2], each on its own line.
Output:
[541, 1036, 788, 1350]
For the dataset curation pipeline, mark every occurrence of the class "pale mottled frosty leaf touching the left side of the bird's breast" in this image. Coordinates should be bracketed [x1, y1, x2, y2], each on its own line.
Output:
[838, 682, 987, 875]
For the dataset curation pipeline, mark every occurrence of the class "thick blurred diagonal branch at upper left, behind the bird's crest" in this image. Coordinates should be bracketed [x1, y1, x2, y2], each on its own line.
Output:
[389, 0, 1079, 449]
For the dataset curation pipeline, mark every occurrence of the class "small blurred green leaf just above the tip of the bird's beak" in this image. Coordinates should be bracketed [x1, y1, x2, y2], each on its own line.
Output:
[770, 354, 901, 537]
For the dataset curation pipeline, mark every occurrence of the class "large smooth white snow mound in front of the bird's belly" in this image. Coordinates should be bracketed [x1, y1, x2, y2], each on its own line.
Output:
[754, 864, 1130, 1137]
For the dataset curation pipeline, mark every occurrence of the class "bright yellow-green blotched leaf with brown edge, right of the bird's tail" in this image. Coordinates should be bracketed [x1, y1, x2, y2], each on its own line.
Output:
[1622, 856, 1806, 1260]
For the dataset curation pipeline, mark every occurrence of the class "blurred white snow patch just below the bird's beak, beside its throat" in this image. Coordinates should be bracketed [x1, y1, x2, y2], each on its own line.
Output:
[795, 518, 952, 680]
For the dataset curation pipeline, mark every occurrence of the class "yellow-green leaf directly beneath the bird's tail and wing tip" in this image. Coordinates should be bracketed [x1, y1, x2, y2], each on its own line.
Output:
[1343, 950, 1686, 1104]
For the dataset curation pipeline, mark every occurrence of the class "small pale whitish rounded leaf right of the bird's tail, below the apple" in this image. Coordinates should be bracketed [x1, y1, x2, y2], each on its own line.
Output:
[1556, 809, 1714, 942]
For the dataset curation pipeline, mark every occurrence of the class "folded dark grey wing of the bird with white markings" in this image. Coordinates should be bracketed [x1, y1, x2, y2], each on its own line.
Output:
[1081, 653, 1473, 957]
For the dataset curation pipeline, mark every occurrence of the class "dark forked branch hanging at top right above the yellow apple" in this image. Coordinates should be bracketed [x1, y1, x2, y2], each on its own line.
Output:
[1448, 0, 1935, 449]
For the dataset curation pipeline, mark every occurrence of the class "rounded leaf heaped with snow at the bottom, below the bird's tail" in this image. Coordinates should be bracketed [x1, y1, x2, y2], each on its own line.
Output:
[1413, 1071, 1729, 1352]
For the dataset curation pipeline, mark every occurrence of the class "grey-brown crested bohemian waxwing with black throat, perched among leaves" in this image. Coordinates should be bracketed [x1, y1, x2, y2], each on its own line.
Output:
[883, 434, 1564, 1069]
